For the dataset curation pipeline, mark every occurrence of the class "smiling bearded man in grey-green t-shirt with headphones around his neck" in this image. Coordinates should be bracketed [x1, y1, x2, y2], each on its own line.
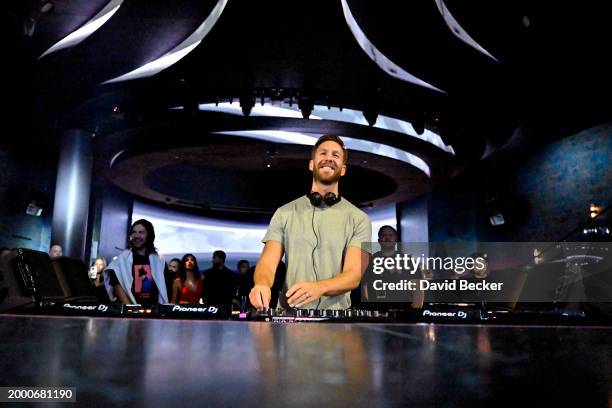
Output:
[249, 135, 372, 309]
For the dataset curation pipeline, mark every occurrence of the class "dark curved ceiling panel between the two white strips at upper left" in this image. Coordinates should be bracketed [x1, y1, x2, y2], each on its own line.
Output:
[39, 0, 225, 92]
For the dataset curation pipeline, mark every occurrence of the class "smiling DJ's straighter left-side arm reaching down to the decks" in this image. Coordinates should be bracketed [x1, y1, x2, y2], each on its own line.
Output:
[249, 240, 285, 309]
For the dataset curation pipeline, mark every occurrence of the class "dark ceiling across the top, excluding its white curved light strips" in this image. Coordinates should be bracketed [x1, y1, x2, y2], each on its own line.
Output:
[7, 0, 612, 217]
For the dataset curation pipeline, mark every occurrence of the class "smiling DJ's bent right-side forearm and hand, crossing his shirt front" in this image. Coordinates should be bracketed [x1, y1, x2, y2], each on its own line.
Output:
[287, 246, 370, 307]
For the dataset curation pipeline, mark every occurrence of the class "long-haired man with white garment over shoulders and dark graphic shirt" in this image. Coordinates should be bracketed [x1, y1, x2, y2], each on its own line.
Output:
[105, 220, 168, 306]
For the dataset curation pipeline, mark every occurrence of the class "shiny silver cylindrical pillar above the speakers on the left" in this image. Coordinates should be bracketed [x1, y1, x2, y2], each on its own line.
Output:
[51, 129, 93, 259]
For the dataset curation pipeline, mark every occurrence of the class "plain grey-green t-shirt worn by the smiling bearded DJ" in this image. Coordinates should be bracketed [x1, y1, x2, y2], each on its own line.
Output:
[262, 196, 372, 309]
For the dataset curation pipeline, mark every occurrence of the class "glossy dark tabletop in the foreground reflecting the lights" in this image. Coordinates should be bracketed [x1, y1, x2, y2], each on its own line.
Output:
[0, 315, 612, 408]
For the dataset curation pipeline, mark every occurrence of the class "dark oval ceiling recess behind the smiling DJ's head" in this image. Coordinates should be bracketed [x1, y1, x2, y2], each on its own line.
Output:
[107, 135, 430, 213]
